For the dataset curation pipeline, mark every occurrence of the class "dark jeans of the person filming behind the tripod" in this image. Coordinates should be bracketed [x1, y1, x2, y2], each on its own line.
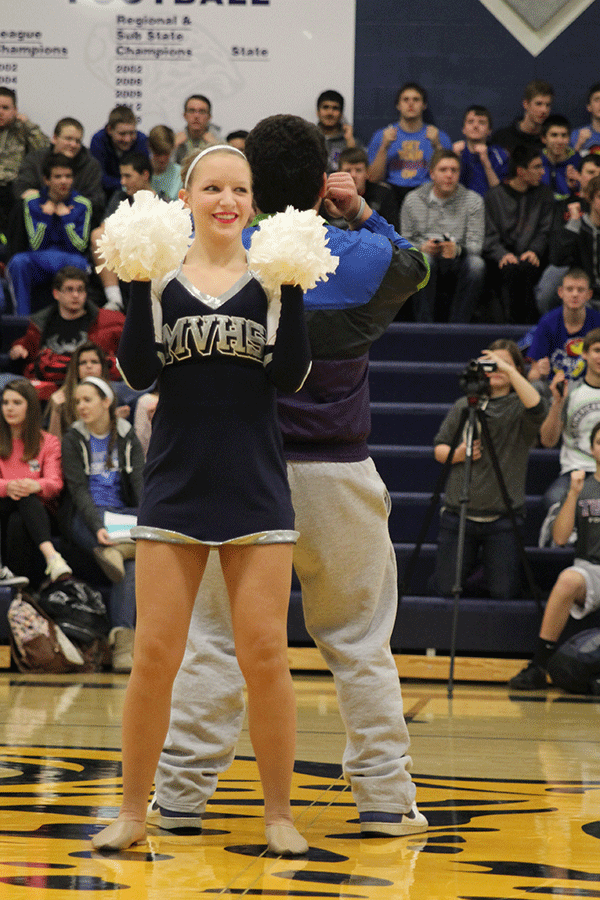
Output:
[434, 511, 522, 600]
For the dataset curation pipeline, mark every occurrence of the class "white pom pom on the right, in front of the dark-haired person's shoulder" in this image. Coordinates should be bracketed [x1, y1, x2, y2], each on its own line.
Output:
[248, 206, 338, 296]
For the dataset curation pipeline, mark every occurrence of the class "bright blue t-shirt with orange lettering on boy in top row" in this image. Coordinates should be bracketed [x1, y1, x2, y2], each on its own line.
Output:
[367, 125, 452, 187]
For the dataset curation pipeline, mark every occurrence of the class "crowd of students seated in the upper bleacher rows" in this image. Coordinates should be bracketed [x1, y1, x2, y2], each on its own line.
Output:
[0, 79, 600, 323]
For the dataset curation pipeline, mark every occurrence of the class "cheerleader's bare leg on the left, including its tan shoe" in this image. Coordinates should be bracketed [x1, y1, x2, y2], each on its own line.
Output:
[92, 541, 210, 850]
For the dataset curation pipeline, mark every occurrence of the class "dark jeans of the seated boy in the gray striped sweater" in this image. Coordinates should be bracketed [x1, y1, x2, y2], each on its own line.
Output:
[413, 253, 485, 323]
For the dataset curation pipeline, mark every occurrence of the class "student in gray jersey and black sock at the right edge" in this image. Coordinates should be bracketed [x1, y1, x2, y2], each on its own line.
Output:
[508, 422, 600, 691]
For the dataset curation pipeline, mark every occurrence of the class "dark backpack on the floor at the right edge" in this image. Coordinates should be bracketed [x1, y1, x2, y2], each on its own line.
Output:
[546, 628, 600, 694]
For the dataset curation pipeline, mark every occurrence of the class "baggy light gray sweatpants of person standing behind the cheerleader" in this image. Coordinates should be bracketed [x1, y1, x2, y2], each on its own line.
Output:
[156, 459, 415, 815]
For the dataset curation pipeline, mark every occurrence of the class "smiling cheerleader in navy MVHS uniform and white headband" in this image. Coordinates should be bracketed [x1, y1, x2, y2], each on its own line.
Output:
[92, 145, 310, 855]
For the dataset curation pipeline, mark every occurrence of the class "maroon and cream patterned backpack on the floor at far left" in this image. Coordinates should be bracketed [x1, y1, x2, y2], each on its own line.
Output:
[7, 593, 85, 673]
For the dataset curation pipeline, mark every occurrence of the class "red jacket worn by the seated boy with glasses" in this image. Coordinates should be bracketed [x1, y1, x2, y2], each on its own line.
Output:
[12, 299, 125, 390]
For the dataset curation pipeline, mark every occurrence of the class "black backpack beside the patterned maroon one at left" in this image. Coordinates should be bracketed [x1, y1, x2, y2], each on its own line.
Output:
[38, 577, 110, 646]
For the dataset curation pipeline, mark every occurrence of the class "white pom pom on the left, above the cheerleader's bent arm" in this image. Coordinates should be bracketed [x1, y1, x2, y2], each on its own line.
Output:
[97, 191, 192, 281]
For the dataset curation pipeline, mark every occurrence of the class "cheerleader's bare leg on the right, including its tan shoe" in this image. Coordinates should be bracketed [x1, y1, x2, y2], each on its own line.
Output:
[220, 544, 308, 854]
